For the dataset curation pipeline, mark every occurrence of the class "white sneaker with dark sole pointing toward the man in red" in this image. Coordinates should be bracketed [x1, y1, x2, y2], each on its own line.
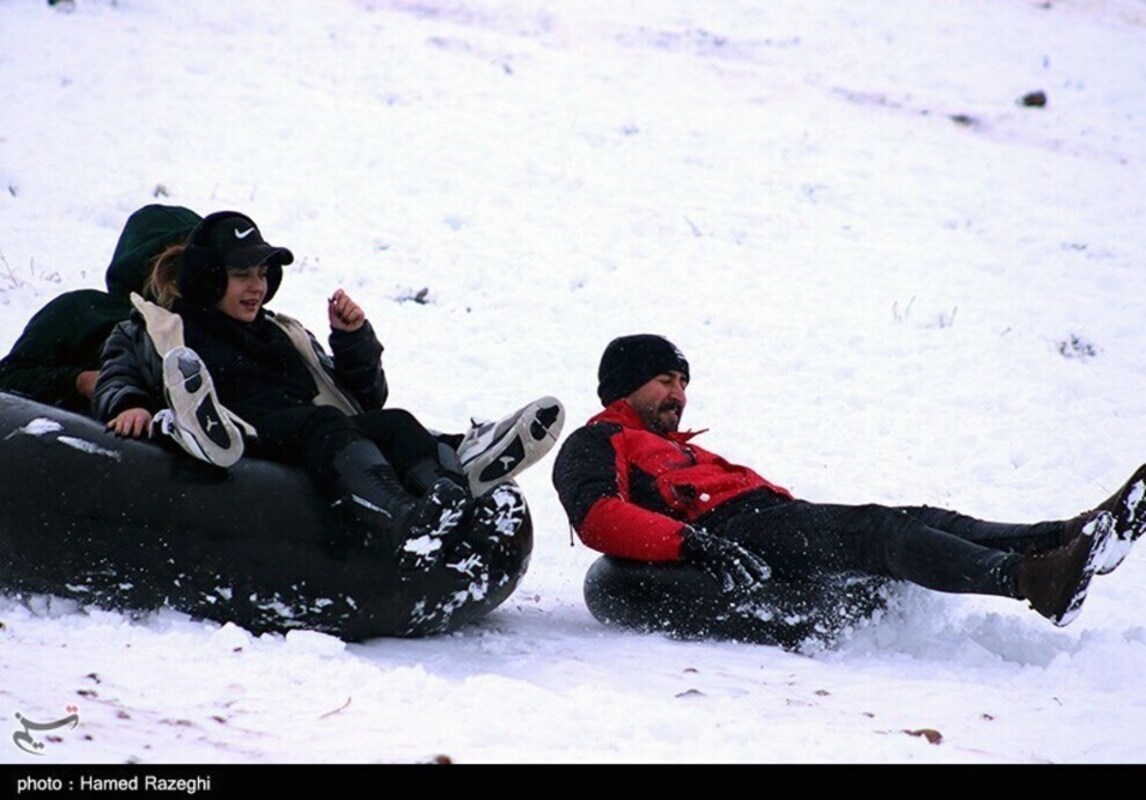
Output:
[457, 397, 565, 497]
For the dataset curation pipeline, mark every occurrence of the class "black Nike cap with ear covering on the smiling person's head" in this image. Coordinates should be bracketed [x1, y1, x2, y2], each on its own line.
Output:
[178, 211, 295, 306]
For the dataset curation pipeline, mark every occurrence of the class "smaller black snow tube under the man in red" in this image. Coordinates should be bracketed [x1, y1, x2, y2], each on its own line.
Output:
[584, 556, 894, 650]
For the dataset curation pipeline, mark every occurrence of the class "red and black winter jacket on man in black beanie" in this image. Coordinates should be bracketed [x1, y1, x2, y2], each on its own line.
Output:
[554, 400, 792, 562]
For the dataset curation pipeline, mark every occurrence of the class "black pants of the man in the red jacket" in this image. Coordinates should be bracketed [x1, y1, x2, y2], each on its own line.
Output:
[698, 492, 1065, 597]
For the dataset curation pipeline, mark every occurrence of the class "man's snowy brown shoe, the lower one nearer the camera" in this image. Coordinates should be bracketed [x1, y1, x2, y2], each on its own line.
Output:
[1014, 511, 1114, 627]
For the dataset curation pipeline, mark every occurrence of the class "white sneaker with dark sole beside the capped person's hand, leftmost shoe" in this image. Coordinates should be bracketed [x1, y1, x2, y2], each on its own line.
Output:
[151, 347, 243, 466]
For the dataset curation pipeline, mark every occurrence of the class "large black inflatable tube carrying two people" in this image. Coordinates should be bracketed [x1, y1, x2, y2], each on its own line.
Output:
[0, 393, 533, 641]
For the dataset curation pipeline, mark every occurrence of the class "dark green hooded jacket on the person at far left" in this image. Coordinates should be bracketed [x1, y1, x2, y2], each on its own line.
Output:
[0, 205, 201, 414]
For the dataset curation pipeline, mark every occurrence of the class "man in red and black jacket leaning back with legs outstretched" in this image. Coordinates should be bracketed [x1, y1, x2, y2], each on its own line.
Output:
[554, 334, 1146, 626]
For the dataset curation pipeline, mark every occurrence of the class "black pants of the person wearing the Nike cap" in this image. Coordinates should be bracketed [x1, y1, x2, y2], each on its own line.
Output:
[248, 406, 438, 497]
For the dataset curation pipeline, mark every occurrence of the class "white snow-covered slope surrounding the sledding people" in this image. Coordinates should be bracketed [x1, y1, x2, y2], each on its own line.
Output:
[0, 0, 1146, 767]
